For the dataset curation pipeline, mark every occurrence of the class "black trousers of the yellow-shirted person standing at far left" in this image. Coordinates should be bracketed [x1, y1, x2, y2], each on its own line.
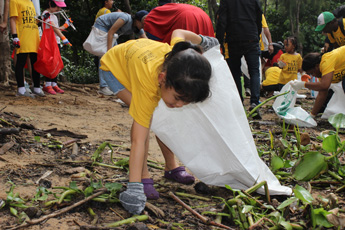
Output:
[15, 53, 40, 88]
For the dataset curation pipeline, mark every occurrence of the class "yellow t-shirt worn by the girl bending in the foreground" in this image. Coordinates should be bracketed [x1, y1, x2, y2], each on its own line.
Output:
[100, 38, 183, 128]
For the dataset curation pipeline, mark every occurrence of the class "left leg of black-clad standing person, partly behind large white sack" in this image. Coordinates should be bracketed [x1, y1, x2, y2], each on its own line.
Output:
[226, 44, 243, 102]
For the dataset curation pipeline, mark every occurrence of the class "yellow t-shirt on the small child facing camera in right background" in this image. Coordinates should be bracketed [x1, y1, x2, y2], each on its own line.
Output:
[278, 53, 302, 85]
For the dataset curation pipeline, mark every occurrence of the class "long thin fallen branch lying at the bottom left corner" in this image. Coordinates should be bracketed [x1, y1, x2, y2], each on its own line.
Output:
[10, 188, 107, 230]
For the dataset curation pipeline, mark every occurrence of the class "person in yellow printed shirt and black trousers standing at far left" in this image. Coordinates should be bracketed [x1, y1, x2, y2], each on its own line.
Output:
[10, 0, 45, 97]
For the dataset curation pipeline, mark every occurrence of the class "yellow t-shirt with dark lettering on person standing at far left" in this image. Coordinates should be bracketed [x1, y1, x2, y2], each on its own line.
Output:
[10, 0, 40, 54]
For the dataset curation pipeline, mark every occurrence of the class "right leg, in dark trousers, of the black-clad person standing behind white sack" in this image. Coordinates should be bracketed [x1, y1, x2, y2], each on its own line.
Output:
[244, 43, 261, 105]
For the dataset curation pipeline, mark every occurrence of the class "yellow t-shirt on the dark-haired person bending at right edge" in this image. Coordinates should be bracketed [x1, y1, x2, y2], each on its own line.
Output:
[320, 46, 345, 83]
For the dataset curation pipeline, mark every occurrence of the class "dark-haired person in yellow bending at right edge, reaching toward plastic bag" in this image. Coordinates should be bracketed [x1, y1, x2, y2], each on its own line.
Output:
[291, 46, 345, 117]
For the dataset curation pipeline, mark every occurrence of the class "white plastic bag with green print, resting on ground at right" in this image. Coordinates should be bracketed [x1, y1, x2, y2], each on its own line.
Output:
[273, 82, 317, 127]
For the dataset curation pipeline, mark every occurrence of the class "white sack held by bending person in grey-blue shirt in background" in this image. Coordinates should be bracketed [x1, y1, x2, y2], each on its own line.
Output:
[83, 26, 119, 57]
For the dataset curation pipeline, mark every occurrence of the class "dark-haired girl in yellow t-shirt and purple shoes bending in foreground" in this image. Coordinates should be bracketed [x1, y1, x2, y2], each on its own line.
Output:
[100, 29, 219, 214]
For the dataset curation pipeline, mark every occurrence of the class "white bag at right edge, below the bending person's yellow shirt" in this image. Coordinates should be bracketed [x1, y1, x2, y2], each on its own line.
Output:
[321, 80, 345, 119]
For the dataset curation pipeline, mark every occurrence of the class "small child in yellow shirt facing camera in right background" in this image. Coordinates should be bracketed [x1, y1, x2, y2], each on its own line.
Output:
[278, 36, 302, 84]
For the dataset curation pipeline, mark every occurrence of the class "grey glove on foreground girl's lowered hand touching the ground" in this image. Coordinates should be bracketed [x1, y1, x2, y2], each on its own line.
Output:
[120, 183, 146, 215]
